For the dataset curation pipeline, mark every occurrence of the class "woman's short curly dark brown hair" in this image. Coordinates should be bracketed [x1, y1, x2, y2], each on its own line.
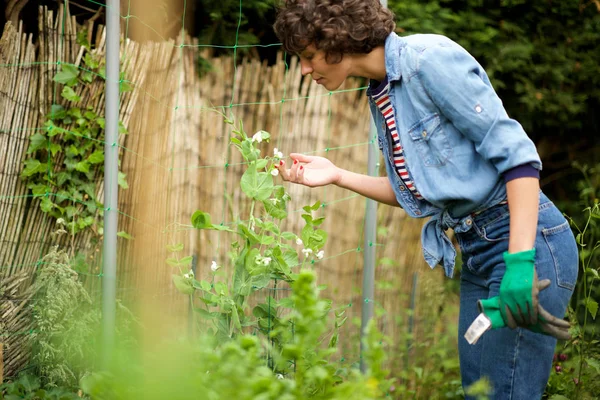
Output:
[274, 0, 396, 63]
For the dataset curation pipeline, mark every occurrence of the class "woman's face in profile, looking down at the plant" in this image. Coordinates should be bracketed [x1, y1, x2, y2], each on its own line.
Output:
[300, 44, 350, 90]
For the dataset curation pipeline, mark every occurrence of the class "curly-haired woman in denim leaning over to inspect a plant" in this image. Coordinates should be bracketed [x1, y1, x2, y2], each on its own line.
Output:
[274, 0, 578, 400]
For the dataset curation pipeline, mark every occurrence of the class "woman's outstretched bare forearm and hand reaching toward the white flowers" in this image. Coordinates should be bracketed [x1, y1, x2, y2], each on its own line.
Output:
[277, 153, 399, 207]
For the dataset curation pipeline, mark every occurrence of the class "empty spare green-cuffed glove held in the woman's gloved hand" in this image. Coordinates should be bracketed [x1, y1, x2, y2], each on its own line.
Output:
[477, 279, 571, 340]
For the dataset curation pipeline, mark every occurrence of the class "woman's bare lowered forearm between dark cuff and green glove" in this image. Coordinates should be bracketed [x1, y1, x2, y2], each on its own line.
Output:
[506, 177, 540, 253]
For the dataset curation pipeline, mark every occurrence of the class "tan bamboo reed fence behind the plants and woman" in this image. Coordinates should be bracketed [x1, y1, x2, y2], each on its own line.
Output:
[0, 8, 441, 376]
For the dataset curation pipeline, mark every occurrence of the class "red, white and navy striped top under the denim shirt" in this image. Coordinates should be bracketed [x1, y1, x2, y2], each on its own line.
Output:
[372, 77, 423, 200]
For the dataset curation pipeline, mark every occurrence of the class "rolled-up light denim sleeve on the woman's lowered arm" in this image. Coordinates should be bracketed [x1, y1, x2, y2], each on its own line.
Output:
[417, 45, 542, 174]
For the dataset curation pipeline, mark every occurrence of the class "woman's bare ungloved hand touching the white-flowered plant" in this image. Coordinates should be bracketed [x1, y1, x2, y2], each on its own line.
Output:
[276, 153, 342, 187]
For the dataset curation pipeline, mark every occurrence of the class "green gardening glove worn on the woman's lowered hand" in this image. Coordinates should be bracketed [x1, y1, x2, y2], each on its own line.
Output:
[498, 249, 539, 329]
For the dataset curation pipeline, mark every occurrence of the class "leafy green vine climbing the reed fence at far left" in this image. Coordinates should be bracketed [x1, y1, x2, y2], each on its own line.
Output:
[21, 32, 131, 235]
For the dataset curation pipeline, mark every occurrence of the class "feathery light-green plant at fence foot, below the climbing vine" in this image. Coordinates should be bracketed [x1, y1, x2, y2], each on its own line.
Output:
[31, 248, 100, 387]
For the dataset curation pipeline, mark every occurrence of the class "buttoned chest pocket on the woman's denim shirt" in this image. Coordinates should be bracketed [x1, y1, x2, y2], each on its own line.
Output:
[408, 113, 451, 167]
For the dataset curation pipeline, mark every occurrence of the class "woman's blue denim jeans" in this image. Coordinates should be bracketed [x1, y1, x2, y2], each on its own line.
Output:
[456, 192, 579, 400]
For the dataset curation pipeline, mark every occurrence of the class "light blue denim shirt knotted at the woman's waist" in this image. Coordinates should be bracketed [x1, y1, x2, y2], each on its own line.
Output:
[367, 33, 542, 277]
